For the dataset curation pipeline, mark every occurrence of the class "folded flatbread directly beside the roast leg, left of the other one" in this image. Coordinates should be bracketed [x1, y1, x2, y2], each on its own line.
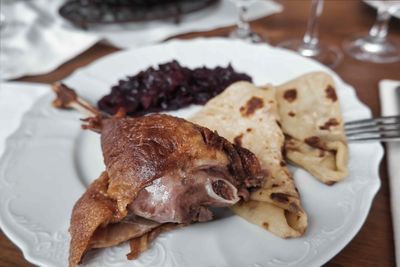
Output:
[190, 82, 307, 238]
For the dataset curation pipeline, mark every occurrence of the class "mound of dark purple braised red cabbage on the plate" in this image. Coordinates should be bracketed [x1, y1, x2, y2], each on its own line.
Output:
[98, 60, 251, 116]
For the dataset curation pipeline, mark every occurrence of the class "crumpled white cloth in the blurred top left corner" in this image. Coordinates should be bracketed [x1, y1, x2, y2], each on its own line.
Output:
[0, 0, 99, 80]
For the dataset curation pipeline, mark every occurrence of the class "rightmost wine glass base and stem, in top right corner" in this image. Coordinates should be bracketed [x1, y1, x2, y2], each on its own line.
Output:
[343, 0, 400, 63]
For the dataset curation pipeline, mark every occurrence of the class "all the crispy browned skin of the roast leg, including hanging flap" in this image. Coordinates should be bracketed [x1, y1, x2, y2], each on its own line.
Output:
[69, 114, 265, 267]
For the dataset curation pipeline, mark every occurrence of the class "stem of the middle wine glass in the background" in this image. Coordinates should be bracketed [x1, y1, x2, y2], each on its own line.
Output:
[303, 0, 324, 49]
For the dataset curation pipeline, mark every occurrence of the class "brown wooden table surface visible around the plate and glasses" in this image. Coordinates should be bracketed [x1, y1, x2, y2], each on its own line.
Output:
[0, 0, 400, 267]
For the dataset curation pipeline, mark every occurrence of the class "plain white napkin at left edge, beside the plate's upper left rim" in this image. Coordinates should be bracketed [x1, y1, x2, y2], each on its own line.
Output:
[0, 82, 50, 157]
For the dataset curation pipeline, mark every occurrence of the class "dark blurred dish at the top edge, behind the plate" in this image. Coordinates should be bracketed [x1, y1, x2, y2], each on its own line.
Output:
[59, 0, 218, 28]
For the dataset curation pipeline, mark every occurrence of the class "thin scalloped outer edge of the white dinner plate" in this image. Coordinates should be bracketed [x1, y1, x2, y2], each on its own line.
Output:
[0, 38, 384, 266]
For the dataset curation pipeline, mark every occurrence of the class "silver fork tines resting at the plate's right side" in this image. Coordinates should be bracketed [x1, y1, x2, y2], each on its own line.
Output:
[344, 115, 400, 142]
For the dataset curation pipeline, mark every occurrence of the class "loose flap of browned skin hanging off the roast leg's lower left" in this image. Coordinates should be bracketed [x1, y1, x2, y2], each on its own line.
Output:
[69, 172, 160, 266]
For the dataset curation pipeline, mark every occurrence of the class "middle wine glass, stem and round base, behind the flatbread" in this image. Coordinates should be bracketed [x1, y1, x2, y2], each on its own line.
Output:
[277, 0, 343, 68]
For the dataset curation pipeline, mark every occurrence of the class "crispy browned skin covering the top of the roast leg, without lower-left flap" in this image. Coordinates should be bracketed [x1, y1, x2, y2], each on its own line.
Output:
[101, 114, 262, 215]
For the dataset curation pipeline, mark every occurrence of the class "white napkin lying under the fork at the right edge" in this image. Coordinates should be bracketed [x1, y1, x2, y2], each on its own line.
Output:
[379, 80, 400, 266]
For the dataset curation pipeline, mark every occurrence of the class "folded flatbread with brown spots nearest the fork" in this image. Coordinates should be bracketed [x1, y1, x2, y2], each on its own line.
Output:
[276, 72, 348, 185]
